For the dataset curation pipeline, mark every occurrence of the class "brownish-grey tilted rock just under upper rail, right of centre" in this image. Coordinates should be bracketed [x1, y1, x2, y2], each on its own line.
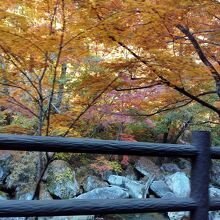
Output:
[135, 157, 162, 179]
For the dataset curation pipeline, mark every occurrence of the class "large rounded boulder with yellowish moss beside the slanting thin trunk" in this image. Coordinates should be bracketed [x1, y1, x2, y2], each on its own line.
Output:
[46, 160, 79, 199]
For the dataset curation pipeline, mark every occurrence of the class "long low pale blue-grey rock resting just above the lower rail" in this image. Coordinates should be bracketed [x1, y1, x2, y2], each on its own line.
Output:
[77, 186, 129, 199]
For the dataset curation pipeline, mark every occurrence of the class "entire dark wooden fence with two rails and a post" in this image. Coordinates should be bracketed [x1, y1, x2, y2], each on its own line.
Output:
[0, 131, 220, 220]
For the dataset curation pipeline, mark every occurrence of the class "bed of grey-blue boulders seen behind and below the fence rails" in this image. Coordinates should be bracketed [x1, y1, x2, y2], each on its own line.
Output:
[0, 153, 220, 220]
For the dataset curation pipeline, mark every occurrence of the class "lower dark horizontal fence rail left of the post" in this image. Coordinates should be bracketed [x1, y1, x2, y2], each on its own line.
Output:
[0, 198, 196, 217]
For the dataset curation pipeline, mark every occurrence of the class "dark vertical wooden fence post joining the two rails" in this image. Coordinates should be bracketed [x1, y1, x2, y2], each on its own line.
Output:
[190, 131, 211, 220]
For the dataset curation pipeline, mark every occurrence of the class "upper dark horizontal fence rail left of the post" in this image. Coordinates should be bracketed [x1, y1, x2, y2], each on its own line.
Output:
[0, 135, 198, 157]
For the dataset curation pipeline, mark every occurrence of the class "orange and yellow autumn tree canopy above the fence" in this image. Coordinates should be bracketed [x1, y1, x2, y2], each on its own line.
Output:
[0, 0, 220, 145]
